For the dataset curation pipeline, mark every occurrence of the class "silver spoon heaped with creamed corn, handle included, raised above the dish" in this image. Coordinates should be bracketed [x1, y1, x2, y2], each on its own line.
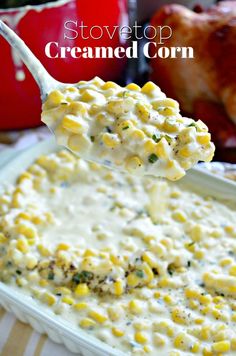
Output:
[0, 21, 214, 180]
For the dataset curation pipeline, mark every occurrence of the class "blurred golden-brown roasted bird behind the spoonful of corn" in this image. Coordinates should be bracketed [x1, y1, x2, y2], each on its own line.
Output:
[151, 1, 236, 161]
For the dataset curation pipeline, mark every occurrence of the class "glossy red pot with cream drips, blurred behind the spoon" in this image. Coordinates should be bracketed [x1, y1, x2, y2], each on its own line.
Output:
[0, 0, 128, 130]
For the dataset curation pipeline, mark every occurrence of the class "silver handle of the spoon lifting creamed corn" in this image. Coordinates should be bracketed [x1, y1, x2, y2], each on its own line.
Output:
[0, 20, 62, 101]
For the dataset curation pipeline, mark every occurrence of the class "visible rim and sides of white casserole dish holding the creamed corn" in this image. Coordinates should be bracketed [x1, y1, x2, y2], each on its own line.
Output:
[0, 140, 236, 356]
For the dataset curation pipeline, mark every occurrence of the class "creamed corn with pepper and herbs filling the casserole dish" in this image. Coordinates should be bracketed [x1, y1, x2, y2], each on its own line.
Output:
[0, 153, 236, 356]
